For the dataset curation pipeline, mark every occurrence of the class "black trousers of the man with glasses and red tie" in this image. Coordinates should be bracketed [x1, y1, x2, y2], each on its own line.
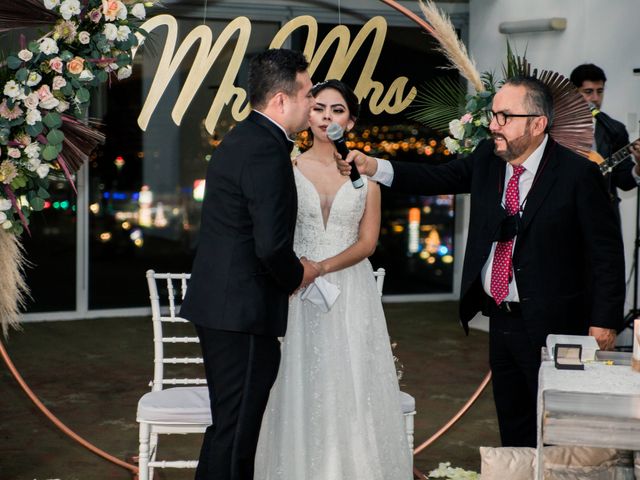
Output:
[489, 305, 540, 447]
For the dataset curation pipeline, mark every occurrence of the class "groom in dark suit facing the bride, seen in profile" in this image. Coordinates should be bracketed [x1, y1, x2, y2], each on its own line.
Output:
[180, 49, 318, 480]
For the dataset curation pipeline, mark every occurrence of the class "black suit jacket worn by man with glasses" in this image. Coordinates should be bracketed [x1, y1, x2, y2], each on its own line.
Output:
[392, 138, 625, 347]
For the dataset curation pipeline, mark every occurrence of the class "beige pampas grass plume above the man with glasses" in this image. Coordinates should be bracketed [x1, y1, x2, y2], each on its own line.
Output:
[420, 0, 485, 92]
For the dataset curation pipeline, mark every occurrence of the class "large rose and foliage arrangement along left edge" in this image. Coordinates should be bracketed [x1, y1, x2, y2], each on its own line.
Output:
[0, 0, 154, 335]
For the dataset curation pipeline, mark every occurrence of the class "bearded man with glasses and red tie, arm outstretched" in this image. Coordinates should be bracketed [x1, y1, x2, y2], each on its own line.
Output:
[338, 77, 625, 447]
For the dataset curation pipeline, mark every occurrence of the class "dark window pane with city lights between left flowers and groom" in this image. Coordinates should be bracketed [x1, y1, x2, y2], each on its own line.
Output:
[89, 19, 280, 309]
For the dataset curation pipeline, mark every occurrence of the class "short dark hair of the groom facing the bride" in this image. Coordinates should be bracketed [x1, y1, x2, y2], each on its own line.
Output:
[249, 48, 309, 109]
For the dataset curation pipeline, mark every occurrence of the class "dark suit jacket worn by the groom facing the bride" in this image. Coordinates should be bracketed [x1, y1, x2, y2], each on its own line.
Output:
[180, 112, 303, 336]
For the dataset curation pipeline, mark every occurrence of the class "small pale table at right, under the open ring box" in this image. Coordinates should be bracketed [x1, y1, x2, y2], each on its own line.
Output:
[537, 352, 640, 479]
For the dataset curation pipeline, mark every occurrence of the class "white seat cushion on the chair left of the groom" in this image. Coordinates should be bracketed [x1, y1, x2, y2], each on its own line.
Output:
[136, 386, 211, 425]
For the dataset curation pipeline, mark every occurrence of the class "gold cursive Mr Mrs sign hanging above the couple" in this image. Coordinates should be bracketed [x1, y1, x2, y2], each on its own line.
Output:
[138, 15, 416, 134]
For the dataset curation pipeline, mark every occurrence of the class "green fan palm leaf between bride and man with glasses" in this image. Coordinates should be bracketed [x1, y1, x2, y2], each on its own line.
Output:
[408, 77, 467, 132]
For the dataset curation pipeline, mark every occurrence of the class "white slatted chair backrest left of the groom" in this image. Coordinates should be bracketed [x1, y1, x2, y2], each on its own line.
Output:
[147, 270, 207, 391]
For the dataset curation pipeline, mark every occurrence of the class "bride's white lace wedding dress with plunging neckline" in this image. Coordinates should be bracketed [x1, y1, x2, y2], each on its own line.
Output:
[254, 168, 412, 480]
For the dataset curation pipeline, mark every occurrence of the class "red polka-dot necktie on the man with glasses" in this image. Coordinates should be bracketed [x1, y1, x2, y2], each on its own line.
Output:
[490, 165, 524, 305]
